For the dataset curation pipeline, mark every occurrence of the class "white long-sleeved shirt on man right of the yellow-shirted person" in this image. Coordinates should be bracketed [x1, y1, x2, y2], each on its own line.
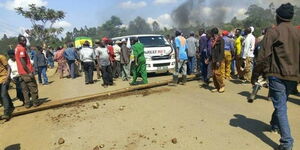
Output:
[242, 33, 255, 59]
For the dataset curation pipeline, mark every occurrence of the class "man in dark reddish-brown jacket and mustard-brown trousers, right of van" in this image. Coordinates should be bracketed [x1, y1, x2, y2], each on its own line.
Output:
[211, 28, 225, 93]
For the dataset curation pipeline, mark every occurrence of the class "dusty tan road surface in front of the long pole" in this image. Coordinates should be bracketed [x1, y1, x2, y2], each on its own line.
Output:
[0, 81, 300, 150]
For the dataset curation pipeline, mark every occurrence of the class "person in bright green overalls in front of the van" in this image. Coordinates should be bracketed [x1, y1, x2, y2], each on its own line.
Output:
[130, 38, 148, 85]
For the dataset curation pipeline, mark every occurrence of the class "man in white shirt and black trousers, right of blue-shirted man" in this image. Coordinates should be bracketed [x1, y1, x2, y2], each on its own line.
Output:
[80, 41, 96, 84]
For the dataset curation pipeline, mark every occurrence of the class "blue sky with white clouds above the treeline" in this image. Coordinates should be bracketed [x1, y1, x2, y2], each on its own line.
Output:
[0, 0, 300, 37]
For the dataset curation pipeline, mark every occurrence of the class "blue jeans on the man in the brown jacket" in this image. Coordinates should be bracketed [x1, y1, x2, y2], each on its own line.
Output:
[269, 77, 297, 148]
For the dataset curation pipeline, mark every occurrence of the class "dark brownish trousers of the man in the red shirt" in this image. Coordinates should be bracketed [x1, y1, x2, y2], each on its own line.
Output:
[20, 75, 38, 104]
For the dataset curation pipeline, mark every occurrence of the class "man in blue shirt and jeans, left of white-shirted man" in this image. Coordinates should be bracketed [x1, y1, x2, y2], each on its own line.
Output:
[64, 43, 79, 79]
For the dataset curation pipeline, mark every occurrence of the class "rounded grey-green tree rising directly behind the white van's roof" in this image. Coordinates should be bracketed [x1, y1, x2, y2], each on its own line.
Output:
[128, 16, 152, 34]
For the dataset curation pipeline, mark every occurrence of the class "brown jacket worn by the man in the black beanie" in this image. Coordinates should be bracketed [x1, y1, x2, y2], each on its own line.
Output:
[254, 22, 300, 81]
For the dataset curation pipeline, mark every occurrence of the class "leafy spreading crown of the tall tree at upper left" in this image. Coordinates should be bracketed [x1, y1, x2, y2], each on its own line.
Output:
[16, 4, 65, 43]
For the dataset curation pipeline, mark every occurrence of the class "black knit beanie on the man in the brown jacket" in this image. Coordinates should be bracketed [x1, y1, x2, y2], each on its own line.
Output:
[276, 3, 294, 21]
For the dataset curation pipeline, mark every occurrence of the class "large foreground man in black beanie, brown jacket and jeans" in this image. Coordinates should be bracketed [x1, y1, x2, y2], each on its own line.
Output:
[251, 3, 300, 150]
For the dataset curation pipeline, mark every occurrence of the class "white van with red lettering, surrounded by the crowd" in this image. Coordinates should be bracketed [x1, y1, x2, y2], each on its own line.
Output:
[112, 34, 175, 73]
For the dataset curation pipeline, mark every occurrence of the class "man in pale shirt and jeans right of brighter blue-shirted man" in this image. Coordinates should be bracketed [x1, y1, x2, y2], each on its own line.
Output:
[186, 32, 199, 75]
